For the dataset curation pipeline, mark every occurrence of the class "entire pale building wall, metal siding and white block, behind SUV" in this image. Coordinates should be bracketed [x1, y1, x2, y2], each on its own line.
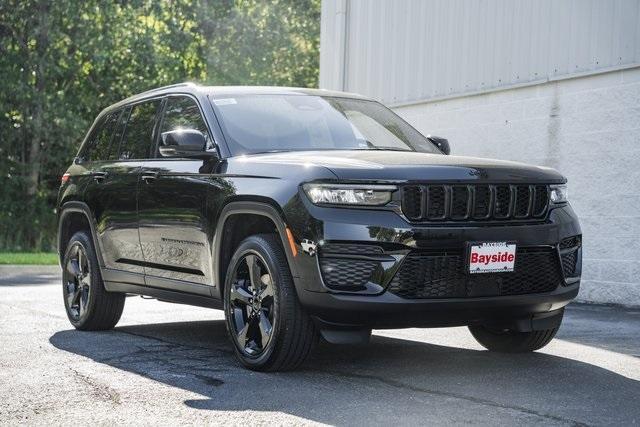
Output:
[320, 0, 640, 306]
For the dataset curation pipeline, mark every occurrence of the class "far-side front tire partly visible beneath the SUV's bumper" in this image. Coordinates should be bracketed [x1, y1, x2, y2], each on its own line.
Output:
[469, 325, 560, 353]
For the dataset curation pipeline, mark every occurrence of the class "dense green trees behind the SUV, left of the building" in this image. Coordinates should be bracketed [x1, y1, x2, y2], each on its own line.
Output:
[0, 0, 320, 250]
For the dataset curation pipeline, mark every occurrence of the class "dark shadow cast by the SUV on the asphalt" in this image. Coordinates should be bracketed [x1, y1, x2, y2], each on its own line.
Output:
[50, 320, 640, 425]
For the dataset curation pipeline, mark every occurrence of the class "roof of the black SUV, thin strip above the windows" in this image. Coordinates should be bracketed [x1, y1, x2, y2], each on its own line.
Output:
[102, 82, 369, 113]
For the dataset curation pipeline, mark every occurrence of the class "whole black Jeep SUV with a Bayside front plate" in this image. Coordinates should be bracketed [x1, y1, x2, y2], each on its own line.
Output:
[58, 84, 582, 370]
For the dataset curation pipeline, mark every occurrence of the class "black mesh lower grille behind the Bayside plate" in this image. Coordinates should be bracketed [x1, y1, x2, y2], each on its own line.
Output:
[388, 248, 563, 299]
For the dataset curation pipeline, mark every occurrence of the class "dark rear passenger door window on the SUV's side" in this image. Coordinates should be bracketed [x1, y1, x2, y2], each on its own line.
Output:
[118, 100, 160, 160]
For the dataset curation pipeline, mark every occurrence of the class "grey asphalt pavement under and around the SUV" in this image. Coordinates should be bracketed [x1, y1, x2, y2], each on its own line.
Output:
[0, 266, 640, 426]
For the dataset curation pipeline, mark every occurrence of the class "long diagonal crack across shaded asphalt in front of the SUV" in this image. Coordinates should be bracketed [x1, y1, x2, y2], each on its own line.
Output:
[311, 369, 588, 427]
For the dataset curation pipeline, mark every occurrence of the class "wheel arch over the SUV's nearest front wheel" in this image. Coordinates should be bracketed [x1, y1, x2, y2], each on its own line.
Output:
[213, 201, 298, 299]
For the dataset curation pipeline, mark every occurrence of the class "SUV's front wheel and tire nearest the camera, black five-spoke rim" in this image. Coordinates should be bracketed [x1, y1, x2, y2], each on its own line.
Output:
[224, 234, 318, 371]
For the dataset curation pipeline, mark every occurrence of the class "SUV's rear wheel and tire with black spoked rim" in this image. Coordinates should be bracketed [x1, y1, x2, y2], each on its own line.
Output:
[62, 231, 125, 331]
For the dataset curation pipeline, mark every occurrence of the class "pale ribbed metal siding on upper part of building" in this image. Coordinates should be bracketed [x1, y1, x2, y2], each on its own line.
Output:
[320, 0, 640, 105]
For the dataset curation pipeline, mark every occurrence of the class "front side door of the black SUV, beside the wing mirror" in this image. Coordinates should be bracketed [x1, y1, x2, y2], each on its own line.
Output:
[138, 95, 213, 295]
